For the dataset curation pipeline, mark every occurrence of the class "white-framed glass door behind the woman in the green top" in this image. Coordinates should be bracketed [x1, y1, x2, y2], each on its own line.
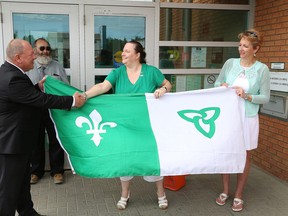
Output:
[85, 6, 155, 88]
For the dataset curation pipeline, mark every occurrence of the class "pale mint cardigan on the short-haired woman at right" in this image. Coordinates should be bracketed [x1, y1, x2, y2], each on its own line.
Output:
[215, 58, 270, 117]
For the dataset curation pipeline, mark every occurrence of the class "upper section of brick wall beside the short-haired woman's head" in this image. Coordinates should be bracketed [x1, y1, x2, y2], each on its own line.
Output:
[254, 0, 288, 66]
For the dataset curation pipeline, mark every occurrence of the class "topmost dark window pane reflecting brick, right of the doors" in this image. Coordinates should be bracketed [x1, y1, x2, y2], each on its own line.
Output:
[159, 8, 248, 41]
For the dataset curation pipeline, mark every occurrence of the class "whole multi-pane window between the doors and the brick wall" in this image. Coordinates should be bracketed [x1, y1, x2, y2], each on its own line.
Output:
[158, 0, 253, 91]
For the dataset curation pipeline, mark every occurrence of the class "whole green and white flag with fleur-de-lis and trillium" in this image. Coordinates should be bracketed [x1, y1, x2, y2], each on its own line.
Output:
[45, 77, 246, 178]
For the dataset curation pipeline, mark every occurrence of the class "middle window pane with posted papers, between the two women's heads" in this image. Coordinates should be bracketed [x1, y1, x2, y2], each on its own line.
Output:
[159, 46, 239, 69]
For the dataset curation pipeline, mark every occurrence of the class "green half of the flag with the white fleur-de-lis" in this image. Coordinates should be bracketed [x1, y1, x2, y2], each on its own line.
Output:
[45, 76, 160, 177]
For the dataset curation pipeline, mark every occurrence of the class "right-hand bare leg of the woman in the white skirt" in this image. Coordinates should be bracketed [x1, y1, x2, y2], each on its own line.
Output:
[235, 151, 251, 199]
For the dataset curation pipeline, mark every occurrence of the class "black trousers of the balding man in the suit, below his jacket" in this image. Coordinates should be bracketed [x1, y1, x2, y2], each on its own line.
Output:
[0, 154, 36, 216]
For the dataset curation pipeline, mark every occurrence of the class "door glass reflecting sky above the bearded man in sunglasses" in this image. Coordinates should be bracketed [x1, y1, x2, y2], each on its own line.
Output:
[12, 13, 70, 68]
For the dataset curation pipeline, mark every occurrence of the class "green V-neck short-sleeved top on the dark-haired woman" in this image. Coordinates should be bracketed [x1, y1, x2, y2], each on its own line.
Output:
[106, 64, 165, 94]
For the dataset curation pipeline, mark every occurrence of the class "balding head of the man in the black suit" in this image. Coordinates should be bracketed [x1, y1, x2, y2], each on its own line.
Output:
[6, 39, 35, 72]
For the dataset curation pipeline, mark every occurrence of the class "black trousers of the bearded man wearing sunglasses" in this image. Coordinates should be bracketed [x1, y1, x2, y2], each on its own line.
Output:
[31, 110, 64, 178]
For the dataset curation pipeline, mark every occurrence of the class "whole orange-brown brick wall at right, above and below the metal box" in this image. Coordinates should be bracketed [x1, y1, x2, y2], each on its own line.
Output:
[252, 0, 288, 181]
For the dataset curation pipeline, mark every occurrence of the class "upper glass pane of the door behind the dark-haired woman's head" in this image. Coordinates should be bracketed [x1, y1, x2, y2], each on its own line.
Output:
[94, 16, 146, 68]
